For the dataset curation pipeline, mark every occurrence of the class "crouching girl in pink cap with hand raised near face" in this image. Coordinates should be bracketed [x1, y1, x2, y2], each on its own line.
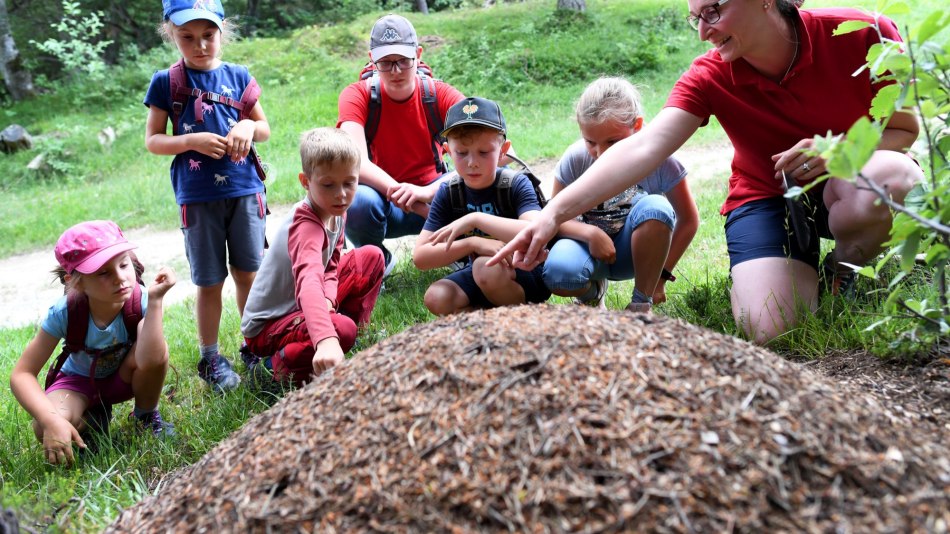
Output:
[10, 221, 175, 463]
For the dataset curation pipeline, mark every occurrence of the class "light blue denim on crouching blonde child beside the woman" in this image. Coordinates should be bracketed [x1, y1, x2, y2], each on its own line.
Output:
[544, 195, 676, 291]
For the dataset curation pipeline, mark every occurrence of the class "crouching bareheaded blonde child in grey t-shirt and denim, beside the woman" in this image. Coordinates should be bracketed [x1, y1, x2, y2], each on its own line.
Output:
[544, 78, 699, 312]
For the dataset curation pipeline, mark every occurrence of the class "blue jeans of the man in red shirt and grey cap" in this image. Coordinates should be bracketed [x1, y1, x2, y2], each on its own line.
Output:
[346, 185, 426, 261]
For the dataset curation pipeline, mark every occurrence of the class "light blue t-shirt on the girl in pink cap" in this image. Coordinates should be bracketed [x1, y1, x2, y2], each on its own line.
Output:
[40, 288, 148, 378]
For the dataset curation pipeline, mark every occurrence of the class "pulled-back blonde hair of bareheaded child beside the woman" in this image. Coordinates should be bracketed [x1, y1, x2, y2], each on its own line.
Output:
[575, 77, 643, 126]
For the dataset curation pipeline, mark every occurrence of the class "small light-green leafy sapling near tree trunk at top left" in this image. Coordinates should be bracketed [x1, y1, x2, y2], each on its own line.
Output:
[30, 0, 112, 82]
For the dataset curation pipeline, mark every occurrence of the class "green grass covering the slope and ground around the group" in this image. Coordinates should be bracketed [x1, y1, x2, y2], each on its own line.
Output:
[0, 0, 939, 531]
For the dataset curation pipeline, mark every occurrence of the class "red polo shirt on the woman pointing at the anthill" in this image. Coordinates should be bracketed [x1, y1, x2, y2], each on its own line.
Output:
[666, 8, 901, 214]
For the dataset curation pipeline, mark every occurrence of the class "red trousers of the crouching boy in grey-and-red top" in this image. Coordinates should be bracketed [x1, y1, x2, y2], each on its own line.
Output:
[245, 246, 385, 386]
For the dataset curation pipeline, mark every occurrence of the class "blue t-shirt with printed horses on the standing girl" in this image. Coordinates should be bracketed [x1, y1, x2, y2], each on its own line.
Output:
[144, 63, 264, 205]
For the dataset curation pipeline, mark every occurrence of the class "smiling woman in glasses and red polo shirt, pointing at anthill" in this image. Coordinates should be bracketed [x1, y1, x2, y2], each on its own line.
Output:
[496, 0, 922, 343]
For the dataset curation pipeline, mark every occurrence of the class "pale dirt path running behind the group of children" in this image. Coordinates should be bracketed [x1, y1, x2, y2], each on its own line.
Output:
[0, 145, 732, 328]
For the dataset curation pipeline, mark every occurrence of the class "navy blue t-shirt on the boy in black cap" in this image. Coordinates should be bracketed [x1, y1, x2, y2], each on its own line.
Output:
[422, 172, 541, 235]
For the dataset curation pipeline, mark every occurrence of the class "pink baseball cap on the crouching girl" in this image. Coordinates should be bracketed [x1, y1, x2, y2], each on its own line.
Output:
[55, 221, 136, 274]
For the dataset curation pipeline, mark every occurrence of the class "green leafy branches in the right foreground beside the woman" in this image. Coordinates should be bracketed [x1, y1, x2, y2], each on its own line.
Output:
[816, 3, 950, 346]
